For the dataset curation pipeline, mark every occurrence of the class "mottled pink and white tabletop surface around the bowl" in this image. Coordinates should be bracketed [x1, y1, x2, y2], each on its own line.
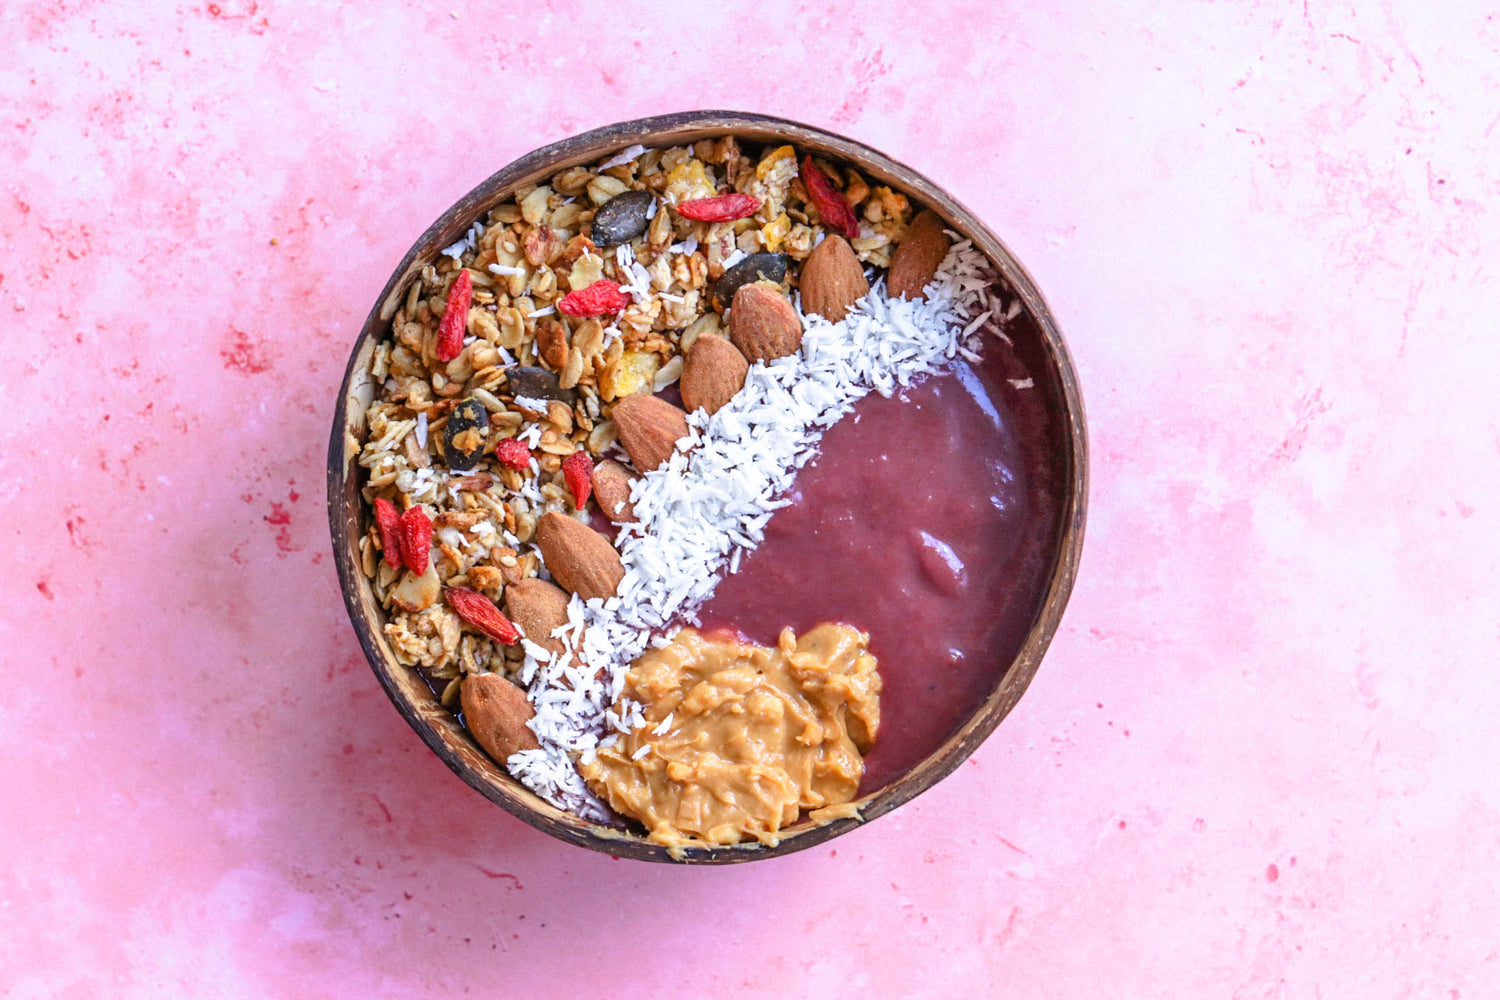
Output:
[0, 0, 1500, 999]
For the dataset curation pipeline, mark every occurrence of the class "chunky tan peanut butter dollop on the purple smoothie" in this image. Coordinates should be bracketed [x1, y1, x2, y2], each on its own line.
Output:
[579, 625, 881, 847]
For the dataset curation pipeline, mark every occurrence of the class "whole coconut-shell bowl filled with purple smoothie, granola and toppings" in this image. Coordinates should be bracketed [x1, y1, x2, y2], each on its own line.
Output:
[329, 111, 1086, 864]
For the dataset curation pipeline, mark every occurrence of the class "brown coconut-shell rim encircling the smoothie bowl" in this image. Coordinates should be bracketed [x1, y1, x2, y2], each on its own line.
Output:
[327, 109, 1088, 864]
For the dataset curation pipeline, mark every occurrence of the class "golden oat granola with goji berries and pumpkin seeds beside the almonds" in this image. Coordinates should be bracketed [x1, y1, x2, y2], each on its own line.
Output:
[359, 136, 912, 706]
